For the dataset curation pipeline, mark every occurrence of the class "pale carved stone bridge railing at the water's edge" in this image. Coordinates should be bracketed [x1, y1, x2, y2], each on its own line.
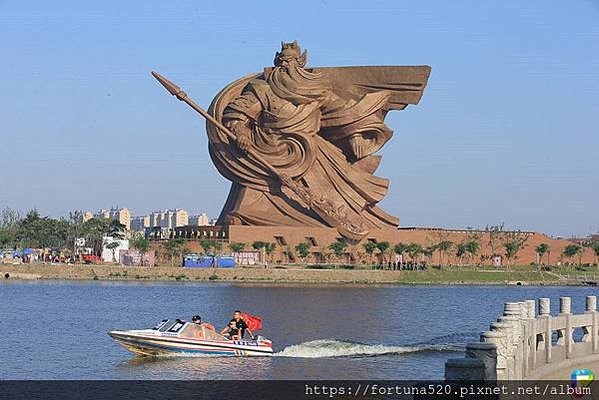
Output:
[445, 296, 599, 381]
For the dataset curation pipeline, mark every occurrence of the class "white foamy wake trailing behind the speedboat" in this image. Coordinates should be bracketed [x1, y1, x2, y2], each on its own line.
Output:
[273, 339, 463, 358]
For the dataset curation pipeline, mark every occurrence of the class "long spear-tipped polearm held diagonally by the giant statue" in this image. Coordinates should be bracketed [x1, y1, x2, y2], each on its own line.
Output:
[152, 71, 368, 240]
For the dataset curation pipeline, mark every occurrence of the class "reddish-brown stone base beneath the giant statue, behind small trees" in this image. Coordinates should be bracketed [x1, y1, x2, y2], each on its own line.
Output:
[175, 225, 596, 265]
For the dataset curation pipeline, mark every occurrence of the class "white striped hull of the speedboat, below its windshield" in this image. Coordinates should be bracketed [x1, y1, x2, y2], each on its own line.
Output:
[108, 331, 273, 357]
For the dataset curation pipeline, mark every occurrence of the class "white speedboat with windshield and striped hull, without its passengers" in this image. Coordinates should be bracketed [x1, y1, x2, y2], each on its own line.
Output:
[108, 319, 273, 357]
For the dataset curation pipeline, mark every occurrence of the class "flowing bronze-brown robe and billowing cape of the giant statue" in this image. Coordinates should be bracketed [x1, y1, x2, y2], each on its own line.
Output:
[207, 67, 430, 229]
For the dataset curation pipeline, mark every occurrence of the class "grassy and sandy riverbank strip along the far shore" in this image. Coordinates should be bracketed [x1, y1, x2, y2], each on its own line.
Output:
[0, 264, 596, 285]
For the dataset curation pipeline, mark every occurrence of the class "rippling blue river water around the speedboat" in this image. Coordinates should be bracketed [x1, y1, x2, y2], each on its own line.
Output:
[0, 280, 597, 379]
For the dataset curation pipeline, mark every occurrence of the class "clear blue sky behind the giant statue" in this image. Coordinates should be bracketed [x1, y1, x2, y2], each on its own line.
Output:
[0, 0, 599, 236]
